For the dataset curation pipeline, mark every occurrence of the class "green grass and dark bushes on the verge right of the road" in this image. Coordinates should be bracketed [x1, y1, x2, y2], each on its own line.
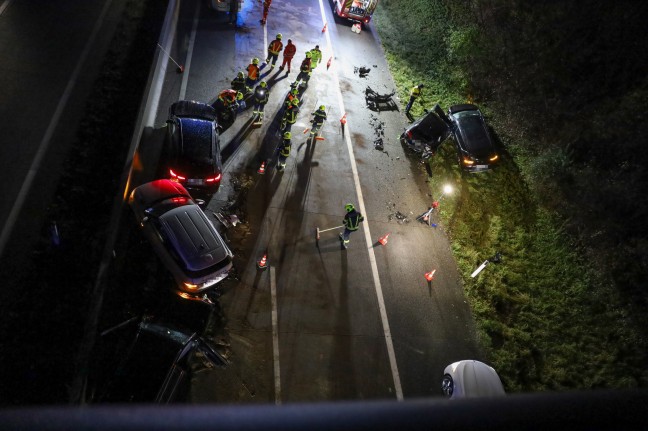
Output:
[375, 0, 648, 392]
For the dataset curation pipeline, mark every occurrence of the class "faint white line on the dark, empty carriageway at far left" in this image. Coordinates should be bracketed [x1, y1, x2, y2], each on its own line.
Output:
[0, 0, 112, 255]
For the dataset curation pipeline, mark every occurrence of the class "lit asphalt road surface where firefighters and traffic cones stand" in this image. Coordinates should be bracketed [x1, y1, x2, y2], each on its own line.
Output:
[86, 0, 481, 404]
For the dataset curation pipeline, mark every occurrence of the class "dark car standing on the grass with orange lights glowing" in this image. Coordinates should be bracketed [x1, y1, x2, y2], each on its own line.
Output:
[448, 104, 499, 172]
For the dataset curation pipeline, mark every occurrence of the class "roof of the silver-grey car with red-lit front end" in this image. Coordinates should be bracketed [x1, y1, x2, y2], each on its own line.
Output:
[160, 204, 228, 271]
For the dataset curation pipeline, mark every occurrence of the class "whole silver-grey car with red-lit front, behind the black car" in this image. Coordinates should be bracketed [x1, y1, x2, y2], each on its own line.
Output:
[129, 180, 233, 302]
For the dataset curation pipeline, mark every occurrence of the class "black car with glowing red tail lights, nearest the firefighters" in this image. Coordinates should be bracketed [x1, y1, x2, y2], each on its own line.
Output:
[163, 100, 223, 194]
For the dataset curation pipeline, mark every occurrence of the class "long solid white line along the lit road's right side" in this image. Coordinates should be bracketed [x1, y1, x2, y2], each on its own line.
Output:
[319, 0, 403, 401]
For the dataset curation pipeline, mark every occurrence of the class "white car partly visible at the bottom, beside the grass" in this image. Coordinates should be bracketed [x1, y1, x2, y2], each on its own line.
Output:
[445, 359, 506, 398]
